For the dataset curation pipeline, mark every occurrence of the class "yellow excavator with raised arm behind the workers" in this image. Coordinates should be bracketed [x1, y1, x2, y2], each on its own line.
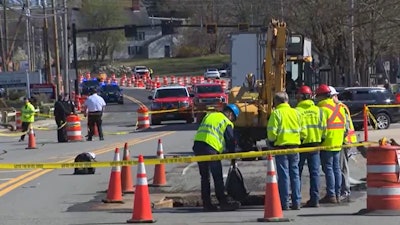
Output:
[229, 19, 312, 151]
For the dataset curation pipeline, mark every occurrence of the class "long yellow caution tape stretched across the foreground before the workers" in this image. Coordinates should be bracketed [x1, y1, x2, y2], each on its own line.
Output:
[0, 142, 377, 170]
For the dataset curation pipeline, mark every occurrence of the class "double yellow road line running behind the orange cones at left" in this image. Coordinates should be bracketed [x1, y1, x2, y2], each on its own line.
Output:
[0, 131, 176, 197]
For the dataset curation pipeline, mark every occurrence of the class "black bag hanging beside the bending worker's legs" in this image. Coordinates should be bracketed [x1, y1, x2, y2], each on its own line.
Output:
[225, 159, 250, 201]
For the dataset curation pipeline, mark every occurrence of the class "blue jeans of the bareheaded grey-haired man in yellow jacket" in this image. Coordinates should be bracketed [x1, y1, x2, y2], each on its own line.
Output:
[275, 154, 301, 209]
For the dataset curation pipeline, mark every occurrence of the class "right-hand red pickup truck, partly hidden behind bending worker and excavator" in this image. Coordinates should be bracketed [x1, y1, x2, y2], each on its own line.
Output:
[192, 83, 228, 123]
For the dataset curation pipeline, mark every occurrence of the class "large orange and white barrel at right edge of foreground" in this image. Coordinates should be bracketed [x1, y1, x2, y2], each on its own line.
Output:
[367, 145, 400, 211]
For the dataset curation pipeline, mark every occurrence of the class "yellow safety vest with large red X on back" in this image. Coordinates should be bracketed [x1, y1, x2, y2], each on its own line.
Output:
[318, 98, 346, 151]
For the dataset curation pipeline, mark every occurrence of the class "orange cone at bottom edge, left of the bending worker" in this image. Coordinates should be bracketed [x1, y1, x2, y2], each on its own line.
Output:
[126, 155, 156, 223]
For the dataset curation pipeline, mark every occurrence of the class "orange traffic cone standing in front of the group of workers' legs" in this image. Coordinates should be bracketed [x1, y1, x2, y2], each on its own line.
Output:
[257, 155, 290, 222]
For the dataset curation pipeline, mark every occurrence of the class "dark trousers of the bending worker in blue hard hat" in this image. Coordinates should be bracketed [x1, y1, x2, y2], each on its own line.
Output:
[193, 141, 226, 206]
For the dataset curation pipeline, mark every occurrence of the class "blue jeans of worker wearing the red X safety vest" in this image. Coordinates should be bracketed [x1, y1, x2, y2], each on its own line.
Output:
[320, 151, 342, 197]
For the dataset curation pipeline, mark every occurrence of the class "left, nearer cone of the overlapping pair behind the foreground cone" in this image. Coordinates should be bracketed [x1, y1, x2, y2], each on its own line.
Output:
[103, 148, 123, 203]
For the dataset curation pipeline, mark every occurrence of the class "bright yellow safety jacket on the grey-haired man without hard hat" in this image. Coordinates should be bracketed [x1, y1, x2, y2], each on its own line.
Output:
[267, 103, 302, 146]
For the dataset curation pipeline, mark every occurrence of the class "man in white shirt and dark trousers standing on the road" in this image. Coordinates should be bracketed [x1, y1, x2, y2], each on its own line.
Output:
[84, 88, 106, 141]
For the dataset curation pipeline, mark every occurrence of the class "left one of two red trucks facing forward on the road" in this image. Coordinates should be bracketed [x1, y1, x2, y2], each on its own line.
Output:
[149, 86, 194, 125]
